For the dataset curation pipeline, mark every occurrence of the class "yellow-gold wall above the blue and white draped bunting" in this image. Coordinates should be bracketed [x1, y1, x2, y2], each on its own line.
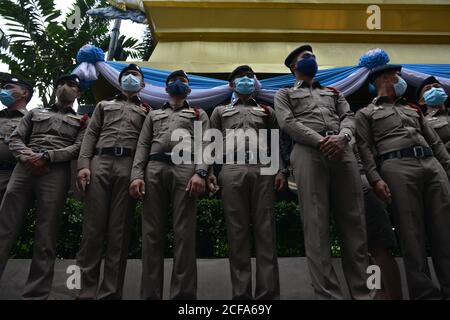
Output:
[144, 0, 450, 73]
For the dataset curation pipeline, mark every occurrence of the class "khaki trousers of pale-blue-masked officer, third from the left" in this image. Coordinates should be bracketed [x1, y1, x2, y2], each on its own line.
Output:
[77, 156, 136, 299]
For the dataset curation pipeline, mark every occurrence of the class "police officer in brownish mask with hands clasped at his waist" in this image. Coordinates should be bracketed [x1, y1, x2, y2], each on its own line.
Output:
[0, 75, 87, 299]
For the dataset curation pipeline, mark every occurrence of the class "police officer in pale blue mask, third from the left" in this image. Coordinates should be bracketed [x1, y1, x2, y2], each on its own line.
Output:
[77, 64, 150, 299]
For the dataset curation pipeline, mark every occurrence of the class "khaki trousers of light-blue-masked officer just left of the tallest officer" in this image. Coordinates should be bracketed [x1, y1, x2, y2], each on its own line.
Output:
[219, 164, 280, 300]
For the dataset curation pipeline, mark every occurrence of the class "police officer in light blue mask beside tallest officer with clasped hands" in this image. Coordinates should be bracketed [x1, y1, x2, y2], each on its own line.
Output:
[211, 66, 286, 300]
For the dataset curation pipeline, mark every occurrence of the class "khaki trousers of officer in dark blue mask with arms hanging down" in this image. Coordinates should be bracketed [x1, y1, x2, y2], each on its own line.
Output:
[141, 161, 197, 300]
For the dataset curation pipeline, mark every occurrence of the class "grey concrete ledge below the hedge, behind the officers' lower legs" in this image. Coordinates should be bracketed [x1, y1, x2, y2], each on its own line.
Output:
[0, 257, 436, 300]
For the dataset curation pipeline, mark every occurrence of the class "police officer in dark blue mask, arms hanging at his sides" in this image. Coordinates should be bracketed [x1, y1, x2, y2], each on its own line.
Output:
[130, 70, 209, 300]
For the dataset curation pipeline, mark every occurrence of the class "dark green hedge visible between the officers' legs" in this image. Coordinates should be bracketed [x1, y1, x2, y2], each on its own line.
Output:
[12, 198, 346, 259]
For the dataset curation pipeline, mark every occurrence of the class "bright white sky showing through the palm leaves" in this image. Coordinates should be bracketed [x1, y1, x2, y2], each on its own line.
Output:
[0, 0, 146, 109]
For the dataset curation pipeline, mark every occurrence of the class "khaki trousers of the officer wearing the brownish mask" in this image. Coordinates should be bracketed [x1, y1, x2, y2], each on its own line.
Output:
[0, 162, 70, 299]
